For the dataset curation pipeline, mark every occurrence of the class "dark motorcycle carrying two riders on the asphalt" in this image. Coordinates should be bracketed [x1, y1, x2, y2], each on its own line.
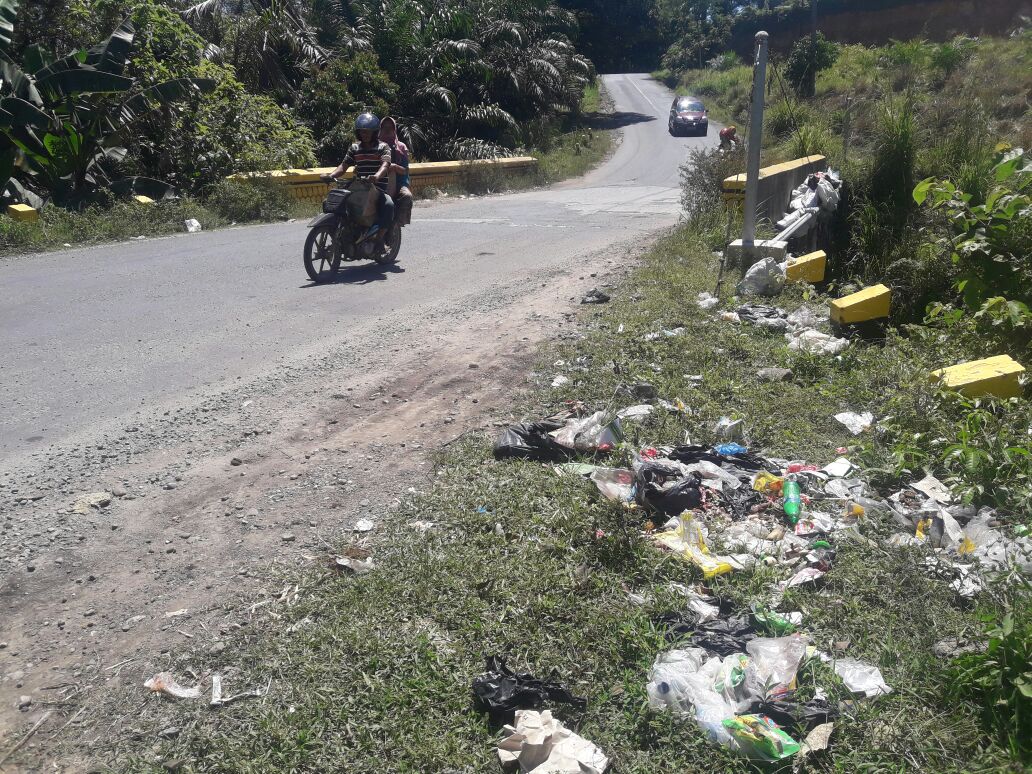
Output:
[304, 178, 401, 283]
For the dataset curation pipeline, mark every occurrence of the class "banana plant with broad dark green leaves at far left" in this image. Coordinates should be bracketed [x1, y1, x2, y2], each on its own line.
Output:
[0, 10, 215, 206]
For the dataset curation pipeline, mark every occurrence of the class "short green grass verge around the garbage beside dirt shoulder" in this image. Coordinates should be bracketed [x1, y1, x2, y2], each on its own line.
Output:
[92, 220, 1019, 774]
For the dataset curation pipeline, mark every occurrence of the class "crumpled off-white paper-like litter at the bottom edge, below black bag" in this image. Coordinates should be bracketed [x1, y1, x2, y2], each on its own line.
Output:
[497, 710, 609, 774]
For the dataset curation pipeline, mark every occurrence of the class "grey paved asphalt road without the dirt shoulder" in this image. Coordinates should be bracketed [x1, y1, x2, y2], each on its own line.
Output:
[0, 74, 718, 471]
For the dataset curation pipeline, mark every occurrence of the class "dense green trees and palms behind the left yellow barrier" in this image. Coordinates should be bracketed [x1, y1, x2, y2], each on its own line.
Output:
[0, 0, 594, 203]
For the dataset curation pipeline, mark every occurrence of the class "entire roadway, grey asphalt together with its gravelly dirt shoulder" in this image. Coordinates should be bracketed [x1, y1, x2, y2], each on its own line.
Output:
[0, 75, 716, 771]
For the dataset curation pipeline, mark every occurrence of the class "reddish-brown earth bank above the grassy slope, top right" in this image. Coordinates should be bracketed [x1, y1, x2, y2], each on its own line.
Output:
[732, 0, 1032, 58]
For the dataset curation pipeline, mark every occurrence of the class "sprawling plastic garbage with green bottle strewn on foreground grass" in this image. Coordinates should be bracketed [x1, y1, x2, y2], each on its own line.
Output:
[494, 402, 1032, 771]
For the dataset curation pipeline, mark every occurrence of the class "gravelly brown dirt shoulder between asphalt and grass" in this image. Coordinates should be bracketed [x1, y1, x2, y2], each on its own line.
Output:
[0, 235, 628, 772]
